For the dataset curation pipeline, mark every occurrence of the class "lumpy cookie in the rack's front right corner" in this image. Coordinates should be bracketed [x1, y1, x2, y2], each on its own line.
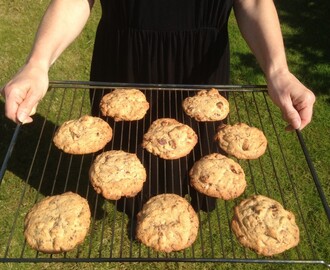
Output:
[231, 195, 299, 256]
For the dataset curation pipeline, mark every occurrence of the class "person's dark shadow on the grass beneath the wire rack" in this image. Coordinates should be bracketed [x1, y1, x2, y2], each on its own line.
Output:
[0, 92, 217, 228]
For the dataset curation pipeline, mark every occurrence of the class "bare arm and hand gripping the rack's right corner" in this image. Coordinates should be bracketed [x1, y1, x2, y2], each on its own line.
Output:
[234, 0, 315, 129]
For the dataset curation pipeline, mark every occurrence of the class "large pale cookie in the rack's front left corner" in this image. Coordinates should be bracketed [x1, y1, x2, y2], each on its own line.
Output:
[24, 192, 91, 253]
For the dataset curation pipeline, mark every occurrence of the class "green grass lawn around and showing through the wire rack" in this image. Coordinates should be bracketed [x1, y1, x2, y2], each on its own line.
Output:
[0, 0, 330, 269]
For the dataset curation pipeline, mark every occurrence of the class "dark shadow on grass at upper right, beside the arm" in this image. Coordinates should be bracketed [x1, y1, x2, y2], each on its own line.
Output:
[232, 0, 330, 97]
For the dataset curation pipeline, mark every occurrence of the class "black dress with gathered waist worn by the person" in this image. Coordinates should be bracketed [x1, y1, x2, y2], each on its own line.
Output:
[90, 0, 233, 215]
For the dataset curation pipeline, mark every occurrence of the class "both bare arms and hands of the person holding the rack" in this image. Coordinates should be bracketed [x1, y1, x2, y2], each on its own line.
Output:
[2, 0, 315, 130]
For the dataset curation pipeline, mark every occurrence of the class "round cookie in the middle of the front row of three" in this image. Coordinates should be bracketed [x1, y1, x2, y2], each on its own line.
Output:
[136, 194, 199, 253]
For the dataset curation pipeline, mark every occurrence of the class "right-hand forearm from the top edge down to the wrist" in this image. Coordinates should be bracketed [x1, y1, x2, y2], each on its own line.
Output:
[234, 0, 288, 78]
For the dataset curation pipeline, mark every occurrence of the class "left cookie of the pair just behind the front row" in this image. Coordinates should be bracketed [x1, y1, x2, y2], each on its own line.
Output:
[89, 150, 147, 200]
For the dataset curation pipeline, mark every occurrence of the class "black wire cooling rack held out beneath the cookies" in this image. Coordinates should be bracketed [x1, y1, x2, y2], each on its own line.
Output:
[0, 82, 330, 266]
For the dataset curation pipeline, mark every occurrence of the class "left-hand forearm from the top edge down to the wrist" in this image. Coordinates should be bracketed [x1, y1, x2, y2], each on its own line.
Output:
[27, 0, 93, 70]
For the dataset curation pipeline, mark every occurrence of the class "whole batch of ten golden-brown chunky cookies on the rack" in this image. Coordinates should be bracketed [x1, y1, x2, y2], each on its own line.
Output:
[24, 89, 299, 256]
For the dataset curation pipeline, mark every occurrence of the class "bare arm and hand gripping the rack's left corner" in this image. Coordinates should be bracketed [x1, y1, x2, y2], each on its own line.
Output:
[3, 0, 94, 123]
